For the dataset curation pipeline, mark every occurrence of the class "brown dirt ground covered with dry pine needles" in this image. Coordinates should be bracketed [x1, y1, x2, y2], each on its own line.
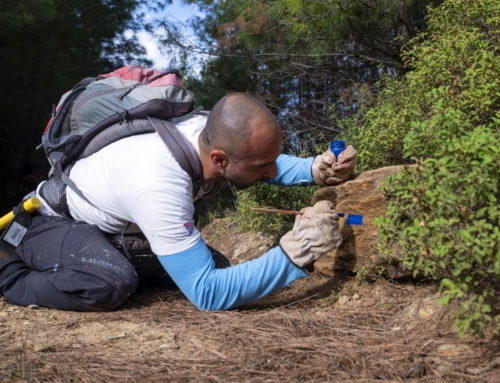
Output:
[0, 220, 500, 382]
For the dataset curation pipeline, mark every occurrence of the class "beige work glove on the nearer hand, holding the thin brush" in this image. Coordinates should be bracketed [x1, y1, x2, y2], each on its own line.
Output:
[280, 201, 342, 268]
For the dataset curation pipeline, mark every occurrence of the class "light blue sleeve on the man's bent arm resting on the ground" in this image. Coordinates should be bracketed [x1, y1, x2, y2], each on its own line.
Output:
[158, 240, 307, 310]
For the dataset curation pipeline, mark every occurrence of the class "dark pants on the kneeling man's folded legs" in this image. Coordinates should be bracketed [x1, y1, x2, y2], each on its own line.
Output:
[0, 216, 139, 311]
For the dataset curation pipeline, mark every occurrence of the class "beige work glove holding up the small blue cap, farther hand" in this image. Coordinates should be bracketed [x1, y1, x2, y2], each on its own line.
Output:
[312, 145, 357, 186]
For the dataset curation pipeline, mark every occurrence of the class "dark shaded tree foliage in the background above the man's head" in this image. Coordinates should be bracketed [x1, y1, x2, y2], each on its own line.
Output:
[160, 0, 441, 140]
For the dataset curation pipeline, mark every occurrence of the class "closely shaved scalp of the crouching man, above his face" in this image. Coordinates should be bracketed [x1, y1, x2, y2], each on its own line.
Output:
[201, 93, 281, 159]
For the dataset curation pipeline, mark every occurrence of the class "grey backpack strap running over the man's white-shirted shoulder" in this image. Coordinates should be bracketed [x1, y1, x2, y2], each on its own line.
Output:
[148, 117, 203, 196]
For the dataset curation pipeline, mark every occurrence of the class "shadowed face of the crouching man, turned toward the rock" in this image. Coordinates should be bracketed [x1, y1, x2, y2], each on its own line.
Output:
[224, 122, 282, 190]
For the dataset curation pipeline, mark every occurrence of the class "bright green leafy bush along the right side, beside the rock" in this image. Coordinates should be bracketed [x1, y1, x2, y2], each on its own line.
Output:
[376, 0, 500, 336]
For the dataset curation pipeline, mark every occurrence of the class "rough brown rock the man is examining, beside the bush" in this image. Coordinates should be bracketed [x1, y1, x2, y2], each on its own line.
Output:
[312, 166, 409, 278]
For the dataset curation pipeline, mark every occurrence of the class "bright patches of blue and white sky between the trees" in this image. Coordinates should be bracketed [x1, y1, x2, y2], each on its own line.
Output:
[138, 0, 203, 69]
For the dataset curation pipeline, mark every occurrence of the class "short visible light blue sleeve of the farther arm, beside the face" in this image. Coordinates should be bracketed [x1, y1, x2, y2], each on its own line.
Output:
[264, 154, 315, 186]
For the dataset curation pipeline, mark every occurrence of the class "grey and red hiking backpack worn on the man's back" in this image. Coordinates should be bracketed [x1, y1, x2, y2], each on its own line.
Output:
[40, 65, 206, 216]
